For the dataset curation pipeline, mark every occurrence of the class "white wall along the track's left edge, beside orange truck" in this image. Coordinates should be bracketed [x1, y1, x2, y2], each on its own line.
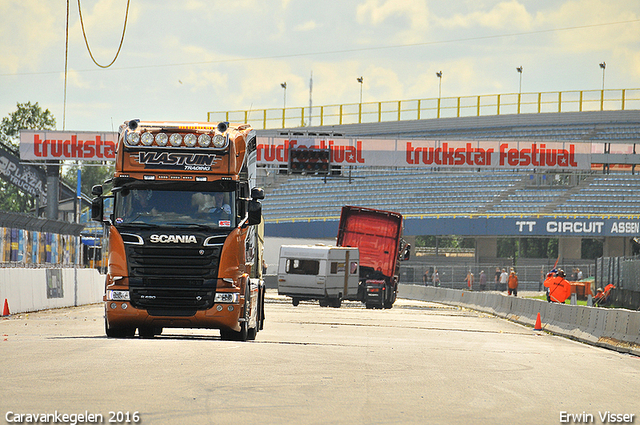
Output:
[0, 268, 104, 314]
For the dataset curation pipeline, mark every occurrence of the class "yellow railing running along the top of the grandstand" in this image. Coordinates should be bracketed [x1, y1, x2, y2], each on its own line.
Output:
[207, 89, 640, 130]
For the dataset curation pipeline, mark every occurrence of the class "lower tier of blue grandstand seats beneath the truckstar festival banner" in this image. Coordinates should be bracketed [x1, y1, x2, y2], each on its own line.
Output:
[264, 168, 640, 221]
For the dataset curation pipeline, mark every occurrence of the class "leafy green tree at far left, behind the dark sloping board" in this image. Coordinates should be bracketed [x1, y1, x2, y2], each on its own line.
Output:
[0, 102, 56, 213]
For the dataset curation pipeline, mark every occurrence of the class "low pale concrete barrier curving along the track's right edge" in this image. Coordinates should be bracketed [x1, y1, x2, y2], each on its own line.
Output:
[398, 284, 640, 356]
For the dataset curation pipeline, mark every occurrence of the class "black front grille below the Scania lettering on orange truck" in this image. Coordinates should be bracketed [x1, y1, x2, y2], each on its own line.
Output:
[126, 245, 222, 316]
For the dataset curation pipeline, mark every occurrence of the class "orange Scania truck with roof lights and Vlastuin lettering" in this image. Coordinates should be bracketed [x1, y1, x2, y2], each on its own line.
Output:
[92, 120, 265, 341]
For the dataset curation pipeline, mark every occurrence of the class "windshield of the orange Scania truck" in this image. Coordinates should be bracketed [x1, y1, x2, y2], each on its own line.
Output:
[114, 189, 236, 228]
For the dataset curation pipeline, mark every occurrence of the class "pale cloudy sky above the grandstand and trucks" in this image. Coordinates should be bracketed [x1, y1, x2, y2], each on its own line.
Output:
[0, 0, 640, 131]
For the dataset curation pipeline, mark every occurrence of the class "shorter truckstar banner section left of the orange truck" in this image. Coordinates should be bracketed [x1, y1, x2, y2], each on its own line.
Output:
[20, 130, 118, 161]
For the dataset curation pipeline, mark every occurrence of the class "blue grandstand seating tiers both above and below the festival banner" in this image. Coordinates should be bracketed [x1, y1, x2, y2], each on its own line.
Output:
[258, 111, 640, 221]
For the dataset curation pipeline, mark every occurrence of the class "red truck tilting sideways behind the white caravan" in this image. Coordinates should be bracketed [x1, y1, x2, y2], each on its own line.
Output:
[337, 206, 410, 308]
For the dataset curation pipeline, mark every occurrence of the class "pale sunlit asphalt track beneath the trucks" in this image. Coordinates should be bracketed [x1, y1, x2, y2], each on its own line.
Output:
[0, 292, 640, 425]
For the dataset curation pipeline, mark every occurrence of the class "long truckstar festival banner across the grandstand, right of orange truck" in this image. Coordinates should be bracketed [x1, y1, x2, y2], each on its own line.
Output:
[257, 137, 591, 170]
